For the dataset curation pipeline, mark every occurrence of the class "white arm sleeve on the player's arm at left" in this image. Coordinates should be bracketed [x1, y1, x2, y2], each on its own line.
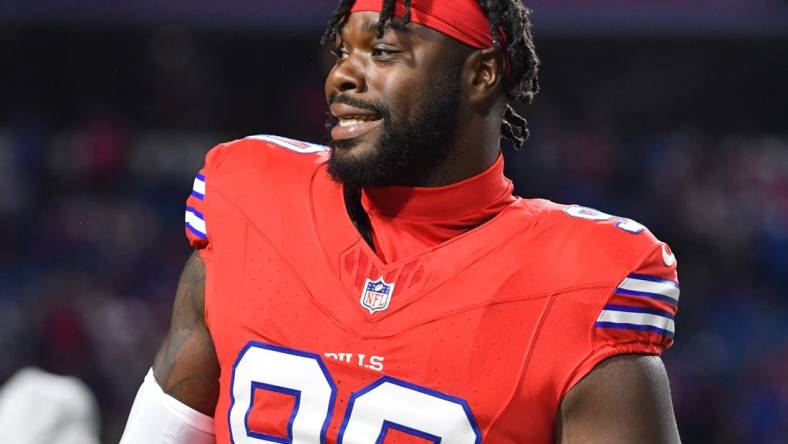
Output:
[120, 369, 216, 444]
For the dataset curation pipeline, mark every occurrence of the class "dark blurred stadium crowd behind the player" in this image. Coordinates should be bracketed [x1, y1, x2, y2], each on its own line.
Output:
[0, 1, 788, 443]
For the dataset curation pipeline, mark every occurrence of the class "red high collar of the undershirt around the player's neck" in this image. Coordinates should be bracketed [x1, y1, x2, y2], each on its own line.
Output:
[361, 156, 515, 263]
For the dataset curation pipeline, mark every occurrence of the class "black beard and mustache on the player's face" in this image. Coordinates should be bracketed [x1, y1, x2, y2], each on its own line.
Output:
[326, 69, 460, 189]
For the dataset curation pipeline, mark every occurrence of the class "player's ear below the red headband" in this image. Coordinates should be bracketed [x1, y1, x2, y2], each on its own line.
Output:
[465, 48, 503, 110]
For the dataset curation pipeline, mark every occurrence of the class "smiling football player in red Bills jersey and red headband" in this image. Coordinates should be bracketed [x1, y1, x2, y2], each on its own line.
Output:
[122, 0, 679, 444]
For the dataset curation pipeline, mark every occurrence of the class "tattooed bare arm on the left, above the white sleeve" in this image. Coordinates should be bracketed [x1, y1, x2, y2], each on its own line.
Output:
[153, 252, 219, 416]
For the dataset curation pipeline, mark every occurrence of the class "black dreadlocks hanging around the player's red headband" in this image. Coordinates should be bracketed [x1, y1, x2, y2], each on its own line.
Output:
[320, 0, 539, 150]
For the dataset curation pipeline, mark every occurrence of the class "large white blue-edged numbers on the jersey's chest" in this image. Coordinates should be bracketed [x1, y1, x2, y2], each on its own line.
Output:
[228, 341, 481, 444]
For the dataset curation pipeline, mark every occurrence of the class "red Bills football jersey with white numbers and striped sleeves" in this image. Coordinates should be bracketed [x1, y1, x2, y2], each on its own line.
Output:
[186, 136, 679, 444]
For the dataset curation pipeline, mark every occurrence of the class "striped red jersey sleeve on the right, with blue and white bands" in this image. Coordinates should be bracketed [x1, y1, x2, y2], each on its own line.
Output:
[566, 242, 680, 390]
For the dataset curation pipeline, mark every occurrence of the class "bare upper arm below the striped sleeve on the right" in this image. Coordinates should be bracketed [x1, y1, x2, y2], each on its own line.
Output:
[556, 355, 680, 444]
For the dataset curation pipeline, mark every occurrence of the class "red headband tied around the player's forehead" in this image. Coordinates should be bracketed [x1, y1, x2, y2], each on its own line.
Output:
[351, 0, 493, 48]
